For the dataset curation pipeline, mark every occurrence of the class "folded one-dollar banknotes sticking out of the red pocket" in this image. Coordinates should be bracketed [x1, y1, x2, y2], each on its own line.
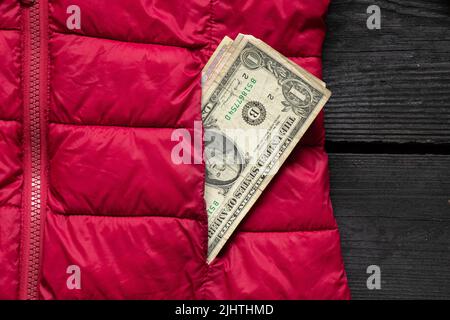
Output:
[202, 34, 331, 263]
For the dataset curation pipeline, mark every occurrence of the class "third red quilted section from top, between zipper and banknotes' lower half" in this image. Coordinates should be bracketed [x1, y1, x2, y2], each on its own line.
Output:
[49, 124, 204, 219]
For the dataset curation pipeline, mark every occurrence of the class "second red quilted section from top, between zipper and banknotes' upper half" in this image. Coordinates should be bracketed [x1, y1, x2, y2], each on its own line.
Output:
[50, 34, 201, 127]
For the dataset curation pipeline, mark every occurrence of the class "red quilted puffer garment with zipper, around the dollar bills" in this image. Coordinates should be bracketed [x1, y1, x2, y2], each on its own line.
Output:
[0, 0, 349, 299]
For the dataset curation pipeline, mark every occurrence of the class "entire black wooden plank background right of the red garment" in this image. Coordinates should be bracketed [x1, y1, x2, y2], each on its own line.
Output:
[324, 0, 450, 299]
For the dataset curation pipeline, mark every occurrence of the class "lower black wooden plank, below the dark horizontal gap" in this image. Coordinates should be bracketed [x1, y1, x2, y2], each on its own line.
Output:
[330, 154, 450, 299]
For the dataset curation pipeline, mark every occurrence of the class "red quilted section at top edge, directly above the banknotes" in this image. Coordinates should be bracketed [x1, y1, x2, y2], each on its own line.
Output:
[213, 0, 329, 57]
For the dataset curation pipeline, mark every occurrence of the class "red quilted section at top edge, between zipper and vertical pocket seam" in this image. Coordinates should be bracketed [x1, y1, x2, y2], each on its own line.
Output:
[49, 0, 211, 49]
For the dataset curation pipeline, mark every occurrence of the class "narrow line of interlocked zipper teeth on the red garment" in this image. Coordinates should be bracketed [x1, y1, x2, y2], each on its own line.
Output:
[27, 1, 41, 300]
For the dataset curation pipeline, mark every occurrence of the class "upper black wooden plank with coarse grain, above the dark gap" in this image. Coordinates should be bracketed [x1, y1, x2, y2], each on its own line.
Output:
[324, 0, 450, 144]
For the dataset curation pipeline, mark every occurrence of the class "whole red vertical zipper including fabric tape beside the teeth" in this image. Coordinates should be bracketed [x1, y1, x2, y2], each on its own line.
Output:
[19, 0, 47, 300]
